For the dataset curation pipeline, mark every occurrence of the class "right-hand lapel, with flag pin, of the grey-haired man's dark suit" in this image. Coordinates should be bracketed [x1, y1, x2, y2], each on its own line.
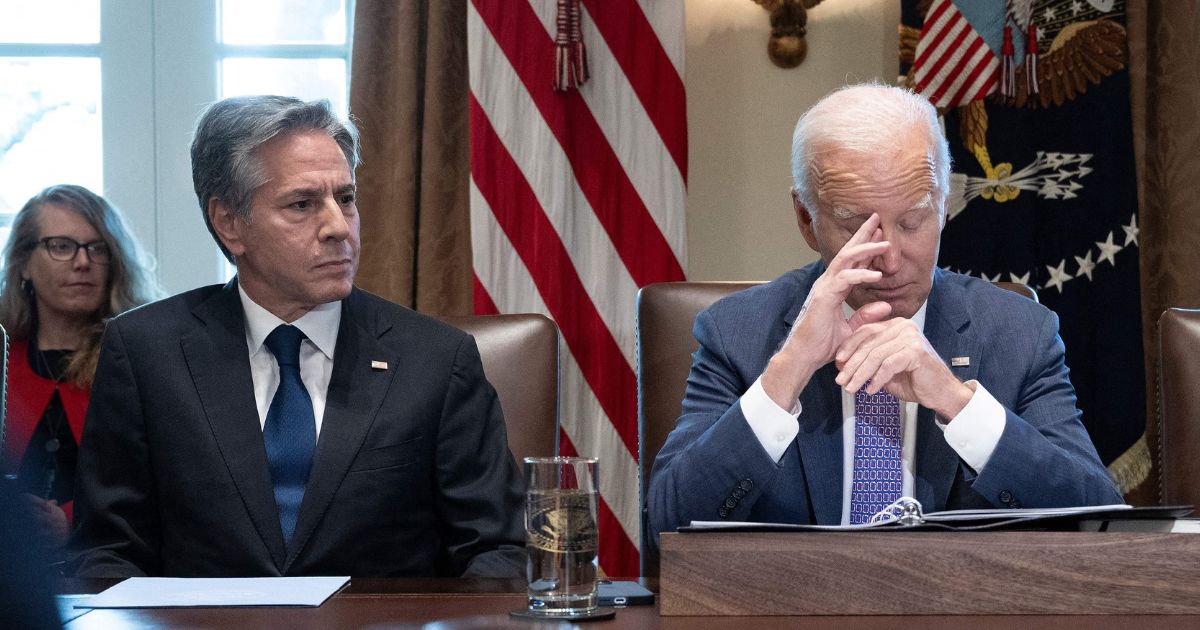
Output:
[283, 289, 396, 572]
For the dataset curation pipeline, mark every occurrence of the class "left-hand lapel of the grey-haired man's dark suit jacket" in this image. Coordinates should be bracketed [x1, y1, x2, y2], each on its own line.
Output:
[180, 280, 284, 566]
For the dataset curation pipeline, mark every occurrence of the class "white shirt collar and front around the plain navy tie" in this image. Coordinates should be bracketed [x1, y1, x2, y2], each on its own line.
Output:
[238, 284, 342, 436]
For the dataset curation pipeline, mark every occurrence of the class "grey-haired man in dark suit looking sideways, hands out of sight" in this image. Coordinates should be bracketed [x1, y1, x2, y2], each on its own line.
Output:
[73, 96, 523, 576]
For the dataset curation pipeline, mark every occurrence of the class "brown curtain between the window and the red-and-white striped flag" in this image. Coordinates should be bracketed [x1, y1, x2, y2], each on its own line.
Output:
[350, 0, 473, 314]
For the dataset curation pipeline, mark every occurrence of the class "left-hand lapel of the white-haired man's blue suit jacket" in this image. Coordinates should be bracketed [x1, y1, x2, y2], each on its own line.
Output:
[779, 265, 842, 524]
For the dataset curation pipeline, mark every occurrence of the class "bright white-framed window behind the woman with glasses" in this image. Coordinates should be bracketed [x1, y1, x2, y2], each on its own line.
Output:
[0, 0, 354, 293]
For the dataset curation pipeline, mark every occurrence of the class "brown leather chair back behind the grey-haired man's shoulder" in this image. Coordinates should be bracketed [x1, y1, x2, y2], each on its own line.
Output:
[442, 313, 558, 456]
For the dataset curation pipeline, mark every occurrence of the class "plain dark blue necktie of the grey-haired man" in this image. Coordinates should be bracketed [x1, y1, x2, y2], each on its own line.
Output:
[263, 324, 317, 542]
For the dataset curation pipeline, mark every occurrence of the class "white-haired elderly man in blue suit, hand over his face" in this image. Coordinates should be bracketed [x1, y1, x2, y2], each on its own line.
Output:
[648, 85, 1122, 545]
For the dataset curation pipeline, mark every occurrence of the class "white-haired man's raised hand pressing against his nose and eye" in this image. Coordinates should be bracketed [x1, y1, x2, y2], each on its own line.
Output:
[762, 214, 892, 409]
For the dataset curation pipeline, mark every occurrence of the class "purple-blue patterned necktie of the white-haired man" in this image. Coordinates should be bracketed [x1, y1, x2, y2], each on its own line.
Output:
[850, 382, 904, 524]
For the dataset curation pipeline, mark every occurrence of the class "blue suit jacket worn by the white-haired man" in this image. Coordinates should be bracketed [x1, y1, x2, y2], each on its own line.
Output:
[648, 263, 1122, 544]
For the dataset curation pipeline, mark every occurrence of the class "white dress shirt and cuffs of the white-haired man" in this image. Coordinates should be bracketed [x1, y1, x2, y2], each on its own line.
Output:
[742, 302, 1006, 524]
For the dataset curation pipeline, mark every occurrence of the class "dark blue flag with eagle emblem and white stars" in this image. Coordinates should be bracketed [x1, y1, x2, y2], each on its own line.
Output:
[900, 0, 1151, 491]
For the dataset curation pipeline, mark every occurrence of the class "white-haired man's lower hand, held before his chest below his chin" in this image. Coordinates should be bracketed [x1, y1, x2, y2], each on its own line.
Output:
[834, 318, 974, 421]
